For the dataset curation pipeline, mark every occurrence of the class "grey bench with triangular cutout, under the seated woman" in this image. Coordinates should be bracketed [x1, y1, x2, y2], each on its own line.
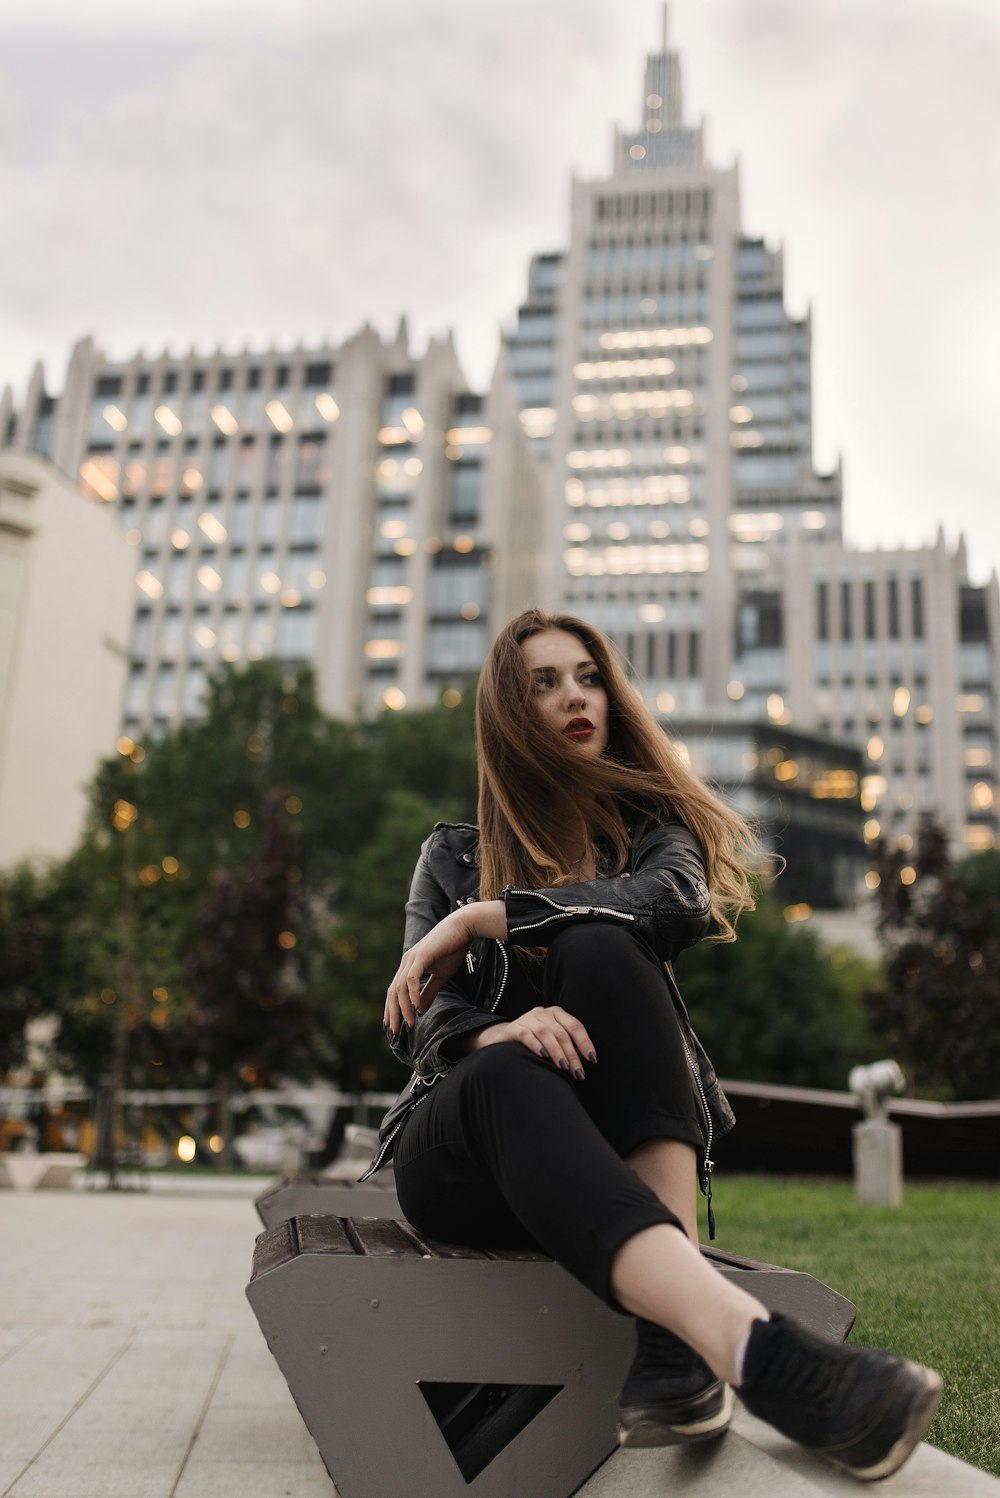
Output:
[247, 1215, 855, 1498]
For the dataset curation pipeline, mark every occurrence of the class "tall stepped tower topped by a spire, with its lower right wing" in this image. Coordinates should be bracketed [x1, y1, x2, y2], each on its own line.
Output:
[504, 17, 1000, 851]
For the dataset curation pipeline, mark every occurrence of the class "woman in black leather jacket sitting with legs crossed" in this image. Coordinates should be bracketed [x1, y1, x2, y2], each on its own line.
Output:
[371, 610, 942, 1480]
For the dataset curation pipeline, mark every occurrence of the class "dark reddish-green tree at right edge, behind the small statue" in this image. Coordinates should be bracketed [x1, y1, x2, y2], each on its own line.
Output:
[868, 849, 1000, 1100]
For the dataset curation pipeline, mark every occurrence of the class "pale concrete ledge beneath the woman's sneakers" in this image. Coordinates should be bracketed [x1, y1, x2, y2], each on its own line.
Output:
[576, 1402, 1000, 1498]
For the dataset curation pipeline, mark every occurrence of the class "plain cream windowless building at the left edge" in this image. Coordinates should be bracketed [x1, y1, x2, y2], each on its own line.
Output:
[0, 449, 136, 867]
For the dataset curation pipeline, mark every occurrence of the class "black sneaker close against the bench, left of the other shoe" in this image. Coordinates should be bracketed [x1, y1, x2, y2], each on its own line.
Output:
[618, 1318, 734, 1446]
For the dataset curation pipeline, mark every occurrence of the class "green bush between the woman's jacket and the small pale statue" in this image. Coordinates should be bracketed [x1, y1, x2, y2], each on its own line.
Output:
[677, 896, 877, 1089]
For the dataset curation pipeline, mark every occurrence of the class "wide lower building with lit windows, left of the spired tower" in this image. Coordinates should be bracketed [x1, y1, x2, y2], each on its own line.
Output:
[7, 324, 539, 737]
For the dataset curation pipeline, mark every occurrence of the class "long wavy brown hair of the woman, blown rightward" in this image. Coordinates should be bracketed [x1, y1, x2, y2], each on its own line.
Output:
[476, 608, 757, 941]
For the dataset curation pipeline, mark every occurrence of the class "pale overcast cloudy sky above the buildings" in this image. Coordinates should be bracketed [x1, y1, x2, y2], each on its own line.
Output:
[0, 0, 1000, 580]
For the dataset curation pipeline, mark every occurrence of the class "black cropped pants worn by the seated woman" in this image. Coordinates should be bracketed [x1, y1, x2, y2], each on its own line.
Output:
[395, 921, 702, 1309]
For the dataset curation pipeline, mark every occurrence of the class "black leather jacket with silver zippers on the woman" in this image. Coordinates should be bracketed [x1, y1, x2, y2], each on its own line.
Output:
[361, 813, 737, 1191]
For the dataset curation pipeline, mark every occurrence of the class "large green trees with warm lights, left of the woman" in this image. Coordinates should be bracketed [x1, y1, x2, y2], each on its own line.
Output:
[0, 661, 476, 1088]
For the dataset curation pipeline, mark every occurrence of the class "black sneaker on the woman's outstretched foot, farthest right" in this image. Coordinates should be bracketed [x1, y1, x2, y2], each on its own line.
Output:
[738, 1315, 943, 1483]
